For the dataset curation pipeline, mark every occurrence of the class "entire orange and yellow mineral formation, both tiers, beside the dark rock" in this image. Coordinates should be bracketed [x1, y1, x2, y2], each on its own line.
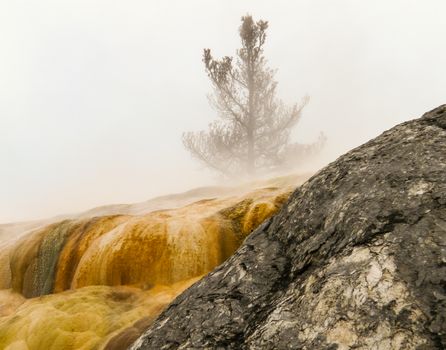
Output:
[0, 178, 300, 350]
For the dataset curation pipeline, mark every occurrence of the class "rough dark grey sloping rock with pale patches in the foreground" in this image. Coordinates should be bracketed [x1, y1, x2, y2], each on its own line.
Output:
[132, 105, 446, 350]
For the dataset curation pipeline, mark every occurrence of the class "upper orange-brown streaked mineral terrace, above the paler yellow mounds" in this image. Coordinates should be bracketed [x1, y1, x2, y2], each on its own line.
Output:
[0, 188, 287, 298]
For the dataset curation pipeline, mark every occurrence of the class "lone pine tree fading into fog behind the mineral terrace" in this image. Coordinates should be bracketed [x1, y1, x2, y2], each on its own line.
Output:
[183, 15, 323, 175]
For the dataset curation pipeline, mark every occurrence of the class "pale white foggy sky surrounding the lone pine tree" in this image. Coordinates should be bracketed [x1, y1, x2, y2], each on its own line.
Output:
[0, 0, 446, 223]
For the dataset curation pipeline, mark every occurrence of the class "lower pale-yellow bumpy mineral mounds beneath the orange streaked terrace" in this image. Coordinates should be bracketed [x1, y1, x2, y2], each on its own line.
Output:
[0, 279, 196, 350]
